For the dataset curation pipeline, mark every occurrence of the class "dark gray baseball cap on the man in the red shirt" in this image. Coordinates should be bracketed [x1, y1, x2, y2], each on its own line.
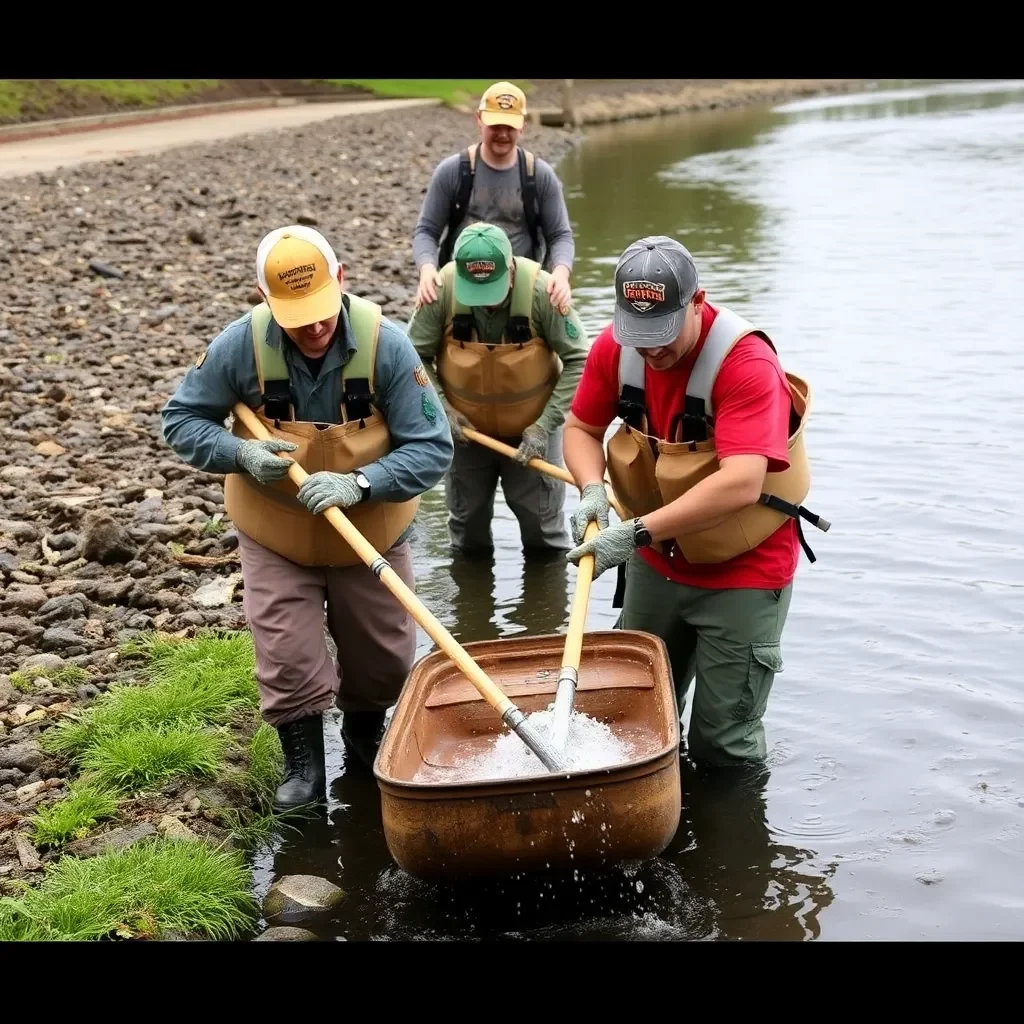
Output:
[611, 234, 697, 348]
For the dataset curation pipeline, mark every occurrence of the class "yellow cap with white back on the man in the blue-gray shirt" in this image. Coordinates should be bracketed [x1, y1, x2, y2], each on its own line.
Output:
[256, 224, 341, 327]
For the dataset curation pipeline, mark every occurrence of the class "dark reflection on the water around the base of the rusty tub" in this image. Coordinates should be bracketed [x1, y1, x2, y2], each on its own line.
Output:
[257, 730, 835, 941]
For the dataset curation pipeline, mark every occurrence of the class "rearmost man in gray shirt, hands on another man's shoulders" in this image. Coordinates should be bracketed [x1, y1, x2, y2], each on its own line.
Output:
[413, 82, 575, 315]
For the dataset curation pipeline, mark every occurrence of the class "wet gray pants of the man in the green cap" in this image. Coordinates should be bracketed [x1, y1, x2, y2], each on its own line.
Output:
[444, 429, 572, 552]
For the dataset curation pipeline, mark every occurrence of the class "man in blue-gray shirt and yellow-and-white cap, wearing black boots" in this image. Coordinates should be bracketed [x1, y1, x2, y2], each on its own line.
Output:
[162, 224, 454, 810]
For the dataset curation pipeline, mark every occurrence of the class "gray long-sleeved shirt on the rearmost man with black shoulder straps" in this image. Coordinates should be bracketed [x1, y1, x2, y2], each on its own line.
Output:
[413, 151, 575, 270]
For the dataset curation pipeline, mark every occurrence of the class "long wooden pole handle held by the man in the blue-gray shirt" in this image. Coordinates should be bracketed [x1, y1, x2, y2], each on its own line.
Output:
[233, 402, 515, 716]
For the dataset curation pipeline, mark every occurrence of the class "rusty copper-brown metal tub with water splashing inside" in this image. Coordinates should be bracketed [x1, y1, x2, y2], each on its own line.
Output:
[374, 630, 682, 879]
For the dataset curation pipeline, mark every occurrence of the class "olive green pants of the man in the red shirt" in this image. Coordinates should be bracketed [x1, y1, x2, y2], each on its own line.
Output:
[616, 555, 793, 765]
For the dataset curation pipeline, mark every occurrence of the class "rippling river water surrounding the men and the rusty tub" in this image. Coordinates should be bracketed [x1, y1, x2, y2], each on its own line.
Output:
[249, 81, 1024, 940]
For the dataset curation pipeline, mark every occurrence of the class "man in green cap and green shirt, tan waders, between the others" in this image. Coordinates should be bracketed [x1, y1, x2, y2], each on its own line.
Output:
[408, 223, 589, 552]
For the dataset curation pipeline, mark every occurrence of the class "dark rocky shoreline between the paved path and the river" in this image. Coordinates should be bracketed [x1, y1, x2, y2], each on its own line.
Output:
[0, 79, 872, 929]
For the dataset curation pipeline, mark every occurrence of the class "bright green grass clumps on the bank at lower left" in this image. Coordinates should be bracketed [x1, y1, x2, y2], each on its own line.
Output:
[11, 631, 294, 941]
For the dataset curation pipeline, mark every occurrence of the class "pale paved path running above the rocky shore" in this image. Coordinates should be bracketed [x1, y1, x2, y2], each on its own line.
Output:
[0, 99, 437, 178]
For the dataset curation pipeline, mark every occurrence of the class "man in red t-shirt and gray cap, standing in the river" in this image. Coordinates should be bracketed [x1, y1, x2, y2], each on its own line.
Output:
[563, 236, 828, 764]
